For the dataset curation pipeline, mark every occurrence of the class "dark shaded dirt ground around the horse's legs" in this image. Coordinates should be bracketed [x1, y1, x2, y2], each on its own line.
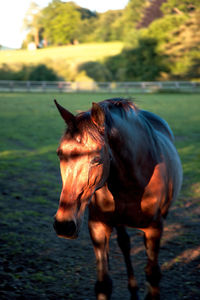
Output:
[0, 178, 200, 300]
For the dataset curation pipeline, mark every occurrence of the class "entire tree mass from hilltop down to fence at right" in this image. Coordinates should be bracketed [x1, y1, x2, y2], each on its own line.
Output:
[16, 0, 200, 81]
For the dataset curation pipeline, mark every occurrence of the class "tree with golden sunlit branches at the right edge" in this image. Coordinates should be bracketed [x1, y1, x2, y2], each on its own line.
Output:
[163, 9, 200, 80]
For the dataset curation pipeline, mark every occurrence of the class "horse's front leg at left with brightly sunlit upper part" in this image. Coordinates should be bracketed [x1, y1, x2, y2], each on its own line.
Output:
[89, 219, 112, 300]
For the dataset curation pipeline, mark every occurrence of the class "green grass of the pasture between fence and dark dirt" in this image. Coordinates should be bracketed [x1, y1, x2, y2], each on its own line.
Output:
[0, 94, 200, 199]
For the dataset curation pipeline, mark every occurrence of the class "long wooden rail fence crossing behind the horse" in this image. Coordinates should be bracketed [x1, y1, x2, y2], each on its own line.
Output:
[0, 80, 200, 94]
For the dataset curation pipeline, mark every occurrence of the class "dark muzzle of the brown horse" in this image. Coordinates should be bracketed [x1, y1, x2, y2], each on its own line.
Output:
[53, 218, 78, 239]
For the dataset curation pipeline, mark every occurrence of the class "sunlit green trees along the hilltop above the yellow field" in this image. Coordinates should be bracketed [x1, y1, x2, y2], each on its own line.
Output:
[23, 0, 145, 47]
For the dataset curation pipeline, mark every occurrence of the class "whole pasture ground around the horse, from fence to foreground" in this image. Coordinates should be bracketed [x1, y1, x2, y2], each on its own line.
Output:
[0, 93, 200, 300]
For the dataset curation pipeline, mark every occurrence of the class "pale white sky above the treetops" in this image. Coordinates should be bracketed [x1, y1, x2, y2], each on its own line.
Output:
[0, 0, 128, 48]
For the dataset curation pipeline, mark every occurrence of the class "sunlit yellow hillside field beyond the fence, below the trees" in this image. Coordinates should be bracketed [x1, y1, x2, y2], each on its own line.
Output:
[0, 42, 123, 80]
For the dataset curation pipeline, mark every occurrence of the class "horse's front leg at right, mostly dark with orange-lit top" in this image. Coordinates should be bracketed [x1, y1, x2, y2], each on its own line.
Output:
[143, 222, 163, 300]
